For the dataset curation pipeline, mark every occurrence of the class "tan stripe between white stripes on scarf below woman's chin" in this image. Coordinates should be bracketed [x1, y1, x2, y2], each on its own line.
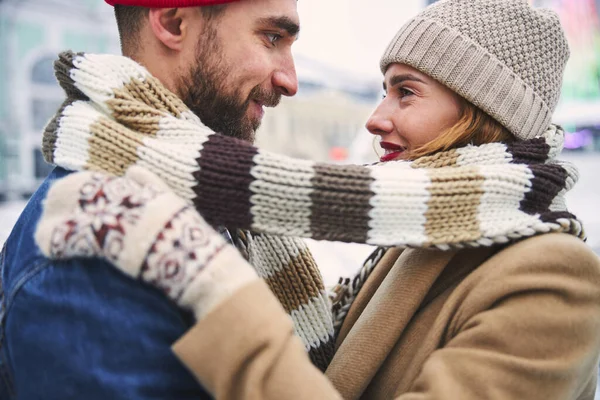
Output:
[425, 167, 485, 244]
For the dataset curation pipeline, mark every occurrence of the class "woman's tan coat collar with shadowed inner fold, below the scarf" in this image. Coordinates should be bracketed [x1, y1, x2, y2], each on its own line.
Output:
[326, 248, 497, 399]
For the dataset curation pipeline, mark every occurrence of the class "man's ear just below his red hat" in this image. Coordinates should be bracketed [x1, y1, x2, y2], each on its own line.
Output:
[148, 8, 192, 51]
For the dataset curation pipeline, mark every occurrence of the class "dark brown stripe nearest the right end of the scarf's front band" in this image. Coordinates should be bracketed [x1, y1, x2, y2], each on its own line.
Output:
[519, 164, 568, 215]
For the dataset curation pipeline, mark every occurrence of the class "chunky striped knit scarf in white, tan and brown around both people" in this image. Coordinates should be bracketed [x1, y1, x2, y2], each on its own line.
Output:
[43, 53, 584, 368]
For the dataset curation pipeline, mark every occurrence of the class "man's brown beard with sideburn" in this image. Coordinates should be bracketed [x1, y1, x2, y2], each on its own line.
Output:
[178, 27, 281, 143]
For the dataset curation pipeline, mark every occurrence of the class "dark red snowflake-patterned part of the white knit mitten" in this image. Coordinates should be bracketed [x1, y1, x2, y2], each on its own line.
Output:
[45, 173, 227, 302]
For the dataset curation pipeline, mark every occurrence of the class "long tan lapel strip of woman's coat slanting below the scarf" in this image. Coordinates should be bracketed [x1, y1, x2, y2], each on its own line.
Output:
[327, 249, 456, 399]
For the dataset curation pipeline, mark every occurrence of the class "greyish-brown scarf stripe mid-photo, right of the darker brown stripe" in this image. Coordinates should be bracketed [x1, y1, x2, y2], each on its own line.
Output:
[310, 164, 375, 243]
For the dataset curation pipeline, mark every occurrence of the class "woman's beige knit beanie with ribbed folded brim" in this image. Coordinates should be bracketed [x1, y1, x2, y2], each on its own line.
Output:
[381, 0, 569, 140]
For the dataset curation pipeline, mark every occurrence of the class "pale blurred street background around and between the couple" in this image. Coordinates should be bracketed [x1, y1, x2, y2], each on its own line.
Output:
[0, 0, 600, 290]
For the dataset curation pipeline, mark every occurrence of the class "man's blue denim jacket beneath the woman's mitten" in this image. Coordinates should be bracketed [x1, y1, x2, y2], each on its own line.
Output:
[0, 168, 210, 400]
